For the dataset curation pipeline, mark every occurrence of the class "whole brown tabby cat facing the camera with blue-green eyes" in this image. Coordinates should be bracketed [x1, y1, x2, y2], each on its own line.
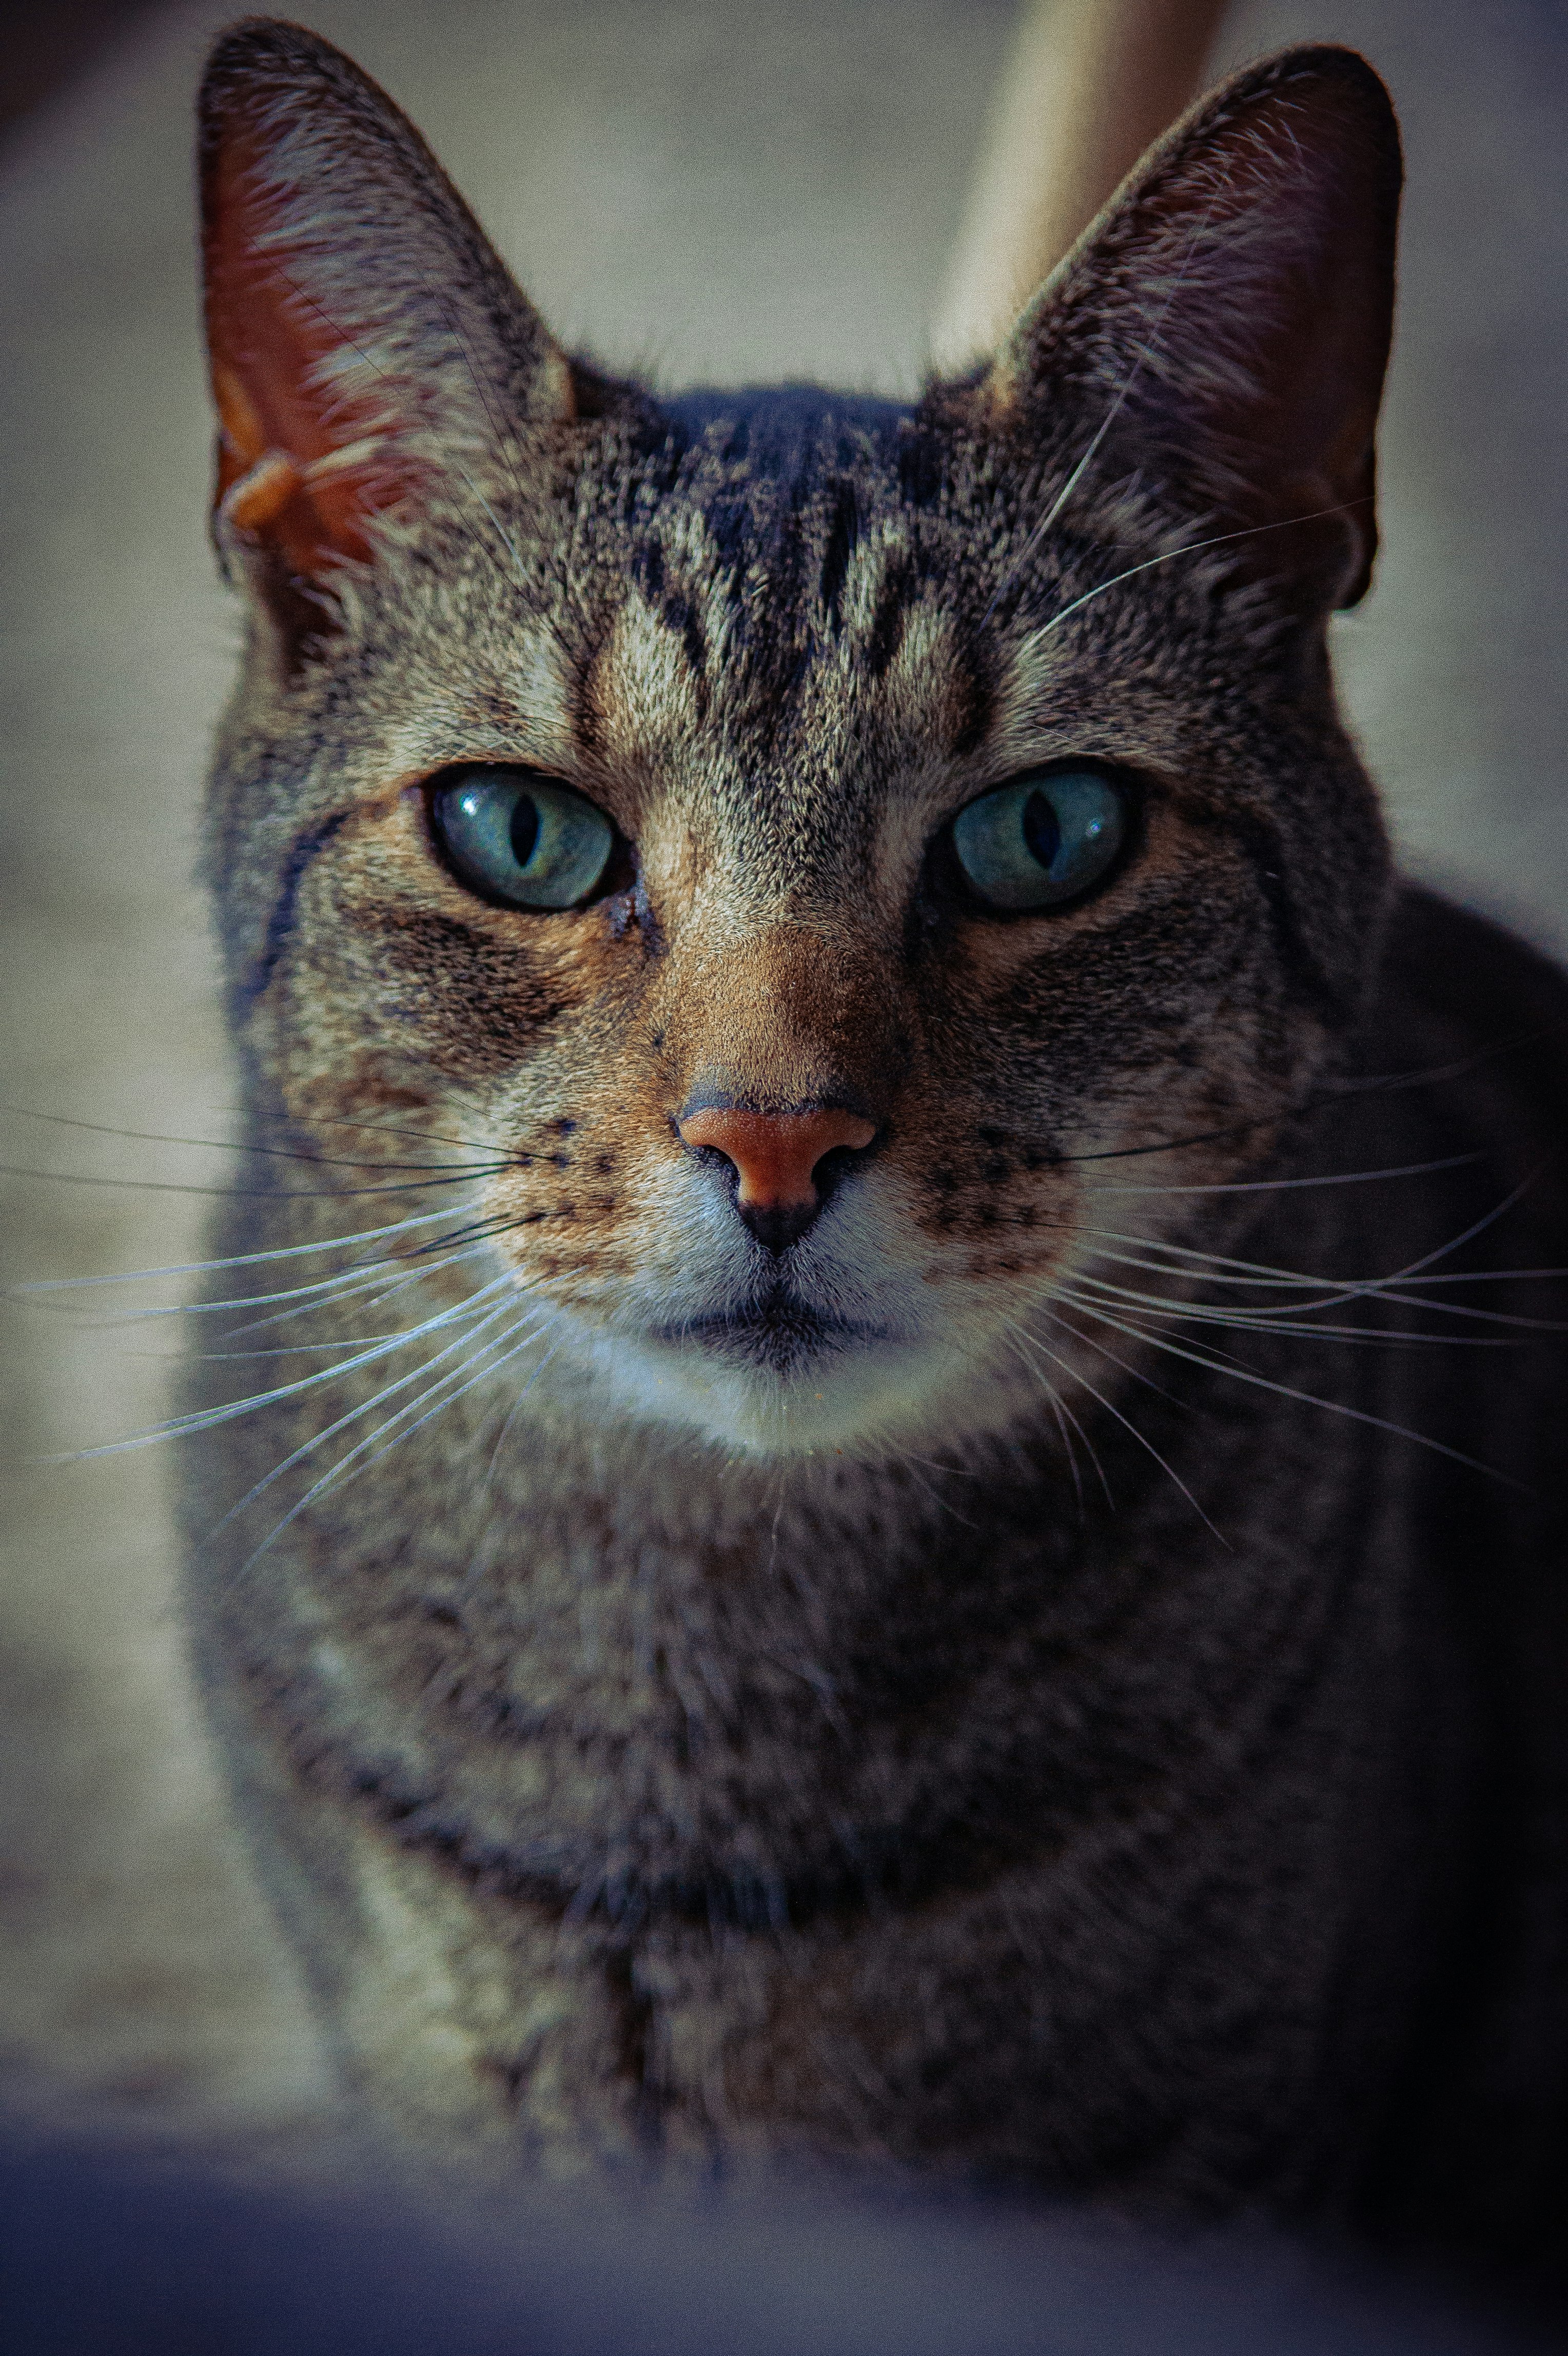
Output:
[184, 21, 1568, 2290]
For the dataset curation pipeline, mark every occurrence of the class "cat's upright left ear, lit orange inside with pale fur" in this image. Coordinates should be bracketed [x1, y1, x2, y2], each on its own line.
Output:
[198, 19, 572, 605]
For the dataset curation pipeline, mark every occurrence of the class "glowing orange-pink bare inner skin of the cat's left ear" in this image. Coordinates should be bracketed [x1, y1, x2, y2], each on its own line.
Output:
[203, 125, 415, 580]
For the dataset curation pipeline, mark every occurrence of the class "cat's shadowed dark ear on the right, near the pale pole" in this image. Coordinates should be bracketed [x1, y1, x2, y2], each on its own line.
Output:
[979, 47, 1401, 613]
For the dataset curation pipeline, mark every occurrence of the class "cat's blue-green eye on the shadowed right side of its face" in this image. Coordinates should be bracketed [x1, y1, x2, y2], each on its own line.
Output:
[953, 768, 1128, 910]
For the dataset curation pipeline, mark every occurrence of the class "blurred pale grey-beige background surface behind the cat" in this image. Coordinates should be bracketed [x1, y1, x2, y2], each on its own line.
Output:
[0, 0, 1568, 2128]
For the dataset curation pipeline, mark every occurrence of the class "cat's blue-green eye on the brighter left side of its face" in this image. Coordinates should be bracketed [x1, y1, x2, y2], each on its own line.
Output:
[431, 768, 615, 907]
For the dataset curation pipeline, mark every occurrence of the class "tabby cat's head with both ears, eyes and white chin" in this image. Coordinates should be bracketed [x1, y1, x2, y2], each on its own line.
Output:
[200, 21, 1399, 1454]
